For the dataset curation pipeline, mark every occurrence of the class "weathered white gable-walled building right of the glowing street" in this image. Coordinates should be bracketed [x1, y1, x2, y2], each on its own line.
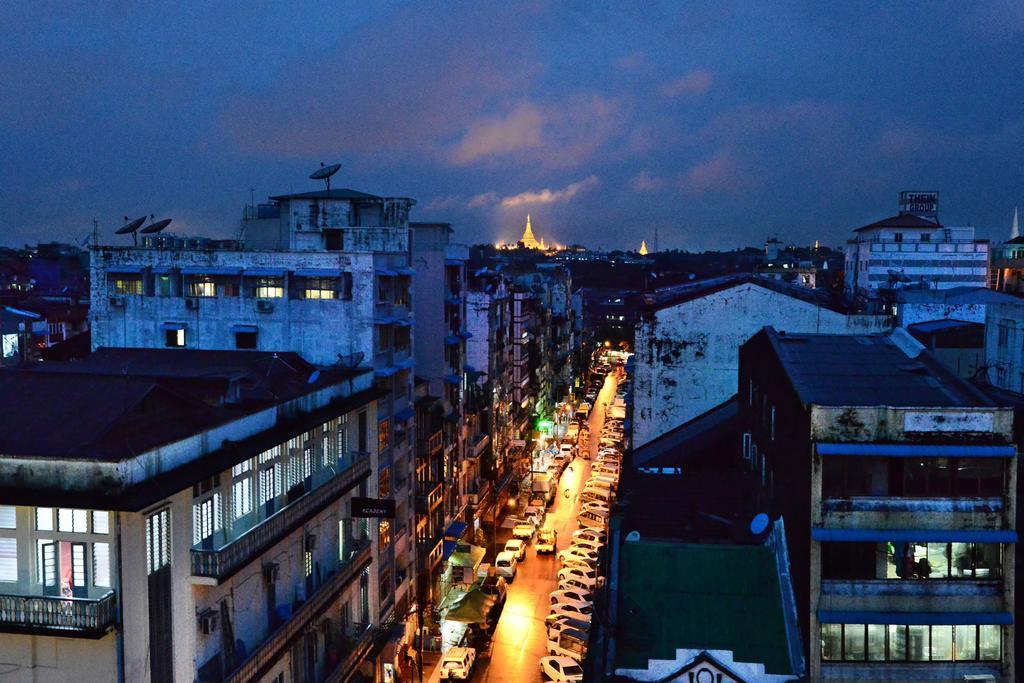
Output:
[632, 275, 891, 447]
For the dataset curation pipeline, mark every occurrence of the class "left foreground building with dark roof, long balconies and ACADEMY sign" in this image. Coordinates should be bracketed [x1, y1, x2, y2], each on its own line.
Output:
[0, 349, 385, 683]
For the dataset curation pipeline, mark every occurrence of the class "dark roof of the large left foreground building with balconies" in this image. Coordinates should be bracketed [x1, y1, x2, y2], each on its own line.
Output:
[0, 348, 370, 461]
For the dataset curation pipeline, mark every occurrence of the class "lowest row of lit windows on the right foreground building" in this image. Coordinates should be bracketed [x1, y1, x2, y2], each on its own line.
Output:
[821, 624, 1002, 661]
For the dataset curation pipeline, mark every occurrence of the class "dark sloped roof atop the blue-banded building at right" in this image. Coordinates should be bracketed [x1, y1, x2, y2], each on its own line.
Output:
[758, 328, 993, 408]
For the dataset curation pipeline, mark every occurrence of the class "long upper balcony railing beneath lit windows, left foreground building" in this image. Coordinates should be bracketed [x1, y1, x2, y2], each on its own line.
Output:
[191, 453, 370, 584]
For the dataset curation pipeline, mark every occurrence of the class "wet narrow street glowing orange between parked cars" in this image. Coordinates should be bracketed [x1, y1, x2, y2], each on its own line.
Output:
[473, 375, 615, 682]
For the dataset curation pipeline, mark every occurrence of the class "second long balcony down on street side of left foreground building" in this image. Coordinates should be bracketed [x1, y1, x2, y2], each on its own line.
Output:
[224, 542, 373, 683]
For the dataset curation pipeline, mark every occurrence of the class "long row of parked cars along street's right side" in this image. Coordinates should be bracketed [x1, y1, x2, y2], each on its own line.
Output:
[540, 370, 623, 681]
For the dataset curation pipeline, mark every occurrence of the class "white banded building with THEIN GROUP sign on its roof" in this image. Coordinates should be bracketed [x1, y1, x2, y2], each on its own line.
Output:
[844, 193, 989, 300]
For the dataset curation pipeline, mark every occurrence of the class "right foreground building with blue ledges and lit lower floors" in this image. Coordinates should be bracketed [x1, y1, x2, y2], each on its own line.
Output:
[738, 328, 1017, 681]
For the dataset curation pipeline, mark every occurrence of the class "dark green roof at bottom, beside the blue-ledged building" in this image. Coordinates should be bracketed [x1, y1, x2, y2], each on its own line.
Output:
[615, 539, 793, 674]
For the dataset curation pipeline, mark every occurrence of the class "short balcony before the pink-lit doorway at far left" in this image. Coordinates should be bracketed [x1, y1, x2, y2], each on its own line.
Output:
[0, 591, 118, 638]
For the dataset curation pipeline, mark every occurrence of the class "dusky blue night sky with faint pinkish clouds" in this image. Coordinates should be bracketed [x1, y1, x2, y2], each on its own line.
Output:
[0, 0, 1024, 250]
